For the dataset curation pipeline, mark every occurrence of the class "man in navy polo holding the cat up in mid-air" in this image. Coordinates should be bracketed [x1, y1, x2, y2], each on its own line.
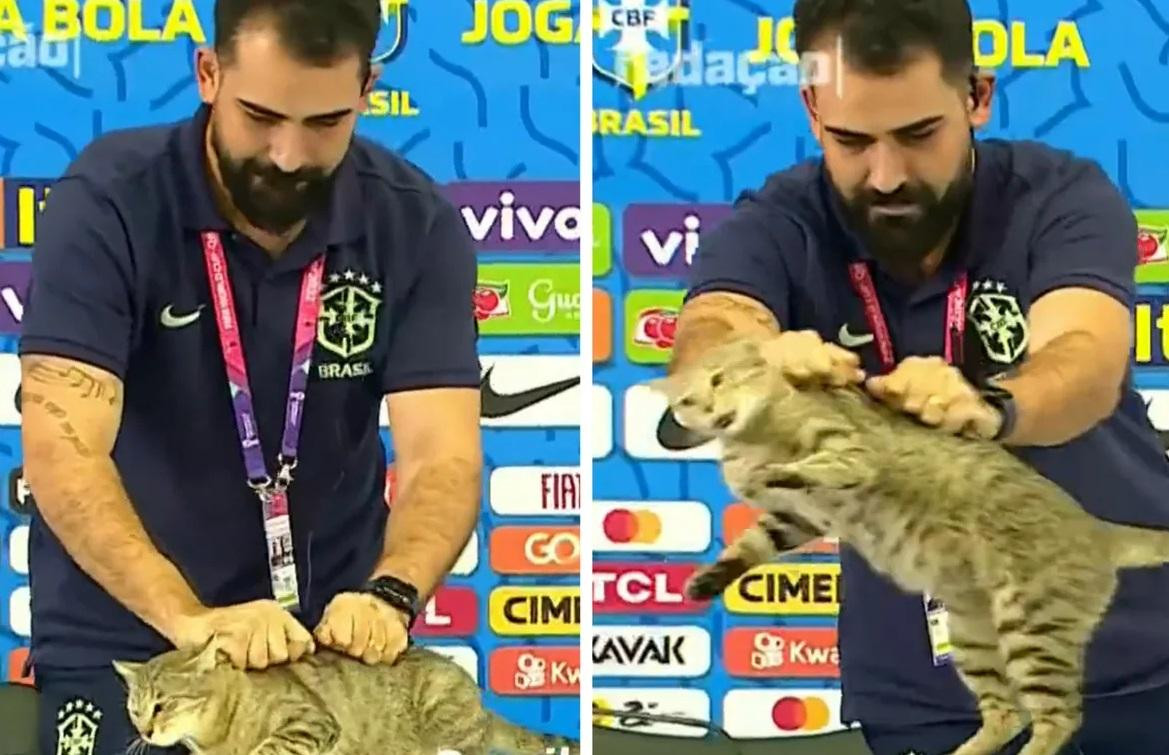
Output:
[671, 0, 1169, 755]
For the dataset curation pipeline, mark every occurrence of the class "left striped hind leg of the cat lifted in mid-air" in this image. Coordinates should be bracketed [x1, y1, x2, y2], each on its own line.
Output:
[946, 590, 1025, 755]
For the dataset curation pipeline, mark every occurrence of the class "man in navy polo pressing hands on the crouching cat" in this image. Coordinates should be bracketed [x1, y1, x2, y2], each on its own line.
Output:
[14, 0, 482, 755]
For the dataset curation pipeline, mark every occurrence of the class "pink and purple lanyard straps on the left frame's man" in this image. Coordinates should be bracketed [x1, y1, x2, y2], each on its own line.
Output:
[202, 231, 325, 499]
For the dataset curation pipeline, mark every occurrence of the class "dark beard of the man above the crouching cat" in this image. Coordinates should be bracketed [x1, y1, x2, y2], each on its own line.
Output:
[210, 122, 333, 235]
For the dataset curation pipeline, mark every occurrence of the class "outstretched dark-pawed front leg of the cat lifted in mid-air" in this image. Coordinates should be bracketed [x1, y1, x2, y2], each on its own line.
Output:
[685, 511, 823, 601]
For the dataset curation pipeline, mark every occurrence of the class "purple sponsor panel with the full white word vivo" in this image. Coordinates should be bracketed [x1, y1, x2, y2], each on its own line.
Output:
[444, 181, 581, 254]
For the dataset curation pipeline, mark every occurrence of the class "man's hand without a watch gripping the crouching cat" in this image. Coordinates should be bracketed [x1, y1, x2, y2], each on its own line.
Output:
[172, 600, 316, 669]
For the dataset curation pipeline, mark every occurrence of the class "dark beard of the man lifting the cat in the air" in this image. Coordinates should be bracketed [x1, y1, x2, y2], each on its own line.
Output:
[832, 150, 974, 275]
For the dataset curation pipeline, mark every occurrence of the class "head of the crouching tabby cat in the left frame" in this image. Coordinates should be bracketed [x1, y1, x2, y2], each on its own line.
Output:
[113, 645, 241, 747]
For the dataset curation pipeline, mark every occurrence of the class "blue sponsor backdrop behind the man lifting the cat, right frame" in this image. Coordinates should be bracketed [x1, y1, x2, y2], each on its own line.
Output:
[587, 0, 1169, 737]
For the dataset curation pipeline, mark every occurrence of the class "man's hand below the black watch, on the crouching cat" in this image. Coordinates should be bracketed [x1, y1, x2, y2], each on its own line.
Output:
[313, 593, 409, 664]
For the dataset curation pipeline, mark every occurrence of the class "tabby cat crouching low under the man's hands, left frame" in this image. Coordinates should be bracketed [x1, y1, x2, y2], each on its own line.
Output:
[113, 642, 580, 755]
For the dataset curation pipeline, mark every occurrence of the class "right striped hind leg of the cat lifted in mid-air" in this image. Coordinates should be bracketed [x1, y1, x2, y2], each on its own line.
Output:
[992, 570, 1116, 755]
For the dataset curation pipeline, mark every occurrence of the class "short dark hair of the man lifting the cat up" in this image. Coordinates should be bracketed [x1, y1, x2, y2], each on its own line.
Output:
[793, 0, 976, 85]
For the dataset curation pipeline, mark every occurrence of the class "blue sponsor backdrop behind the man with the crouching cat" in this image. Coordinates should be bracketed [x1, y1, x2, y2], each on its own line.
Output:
[0, 0, 581, 735]
